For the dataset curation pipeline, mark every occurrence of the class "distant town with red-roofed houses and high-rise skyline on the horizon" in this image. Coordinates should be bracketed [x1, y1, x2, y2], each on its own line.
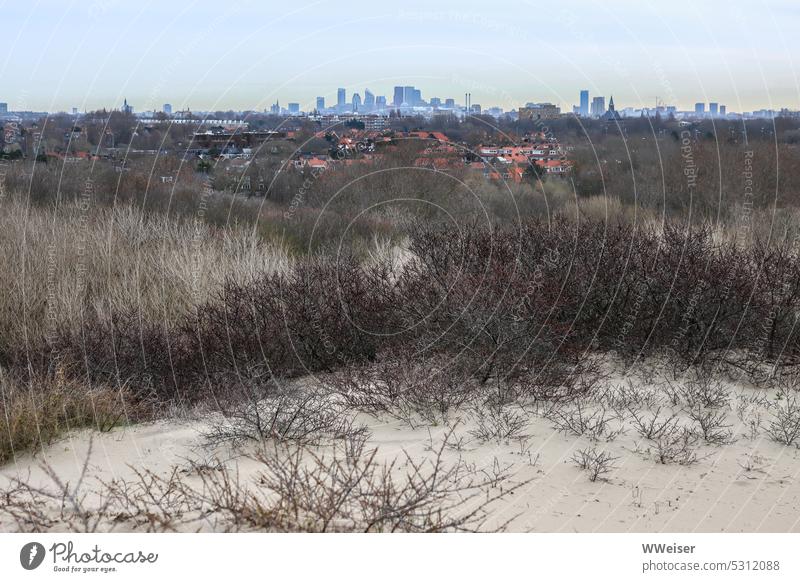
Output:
[0, 86, 800, 189]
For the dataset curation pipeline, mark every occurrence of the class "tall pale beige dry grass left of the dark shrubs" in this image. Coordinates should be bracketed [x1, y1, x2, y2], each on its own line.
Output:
[0, 198, 288, 364]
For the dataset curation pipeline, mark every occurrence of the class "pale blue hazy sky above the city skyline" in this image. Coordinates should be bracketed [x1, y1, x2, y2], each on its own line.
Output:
[0, 0, 800, 111]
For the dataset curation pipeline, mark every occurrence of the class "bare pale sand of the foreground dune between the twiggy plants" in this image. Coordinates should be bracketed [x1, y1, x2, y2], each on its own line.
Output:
[0, 374, 800, 532]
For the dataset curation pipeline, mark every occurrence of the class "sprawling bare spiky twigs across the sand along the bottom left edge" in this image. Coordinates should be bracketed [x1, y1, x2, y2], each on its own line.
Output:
[0, 437, 525, 532]
